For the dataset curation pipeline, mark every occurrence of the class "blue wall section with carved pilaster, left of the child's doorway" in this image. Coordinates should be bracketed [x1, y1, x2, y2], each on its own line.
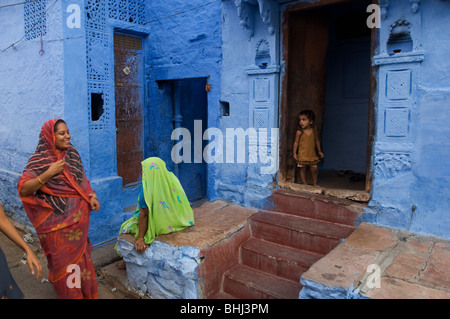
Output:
[220, 1, 280, 207]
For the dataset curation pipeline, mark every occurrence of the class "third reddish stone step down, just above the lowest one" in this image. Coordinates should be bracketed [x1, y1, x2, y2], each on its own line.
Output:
[241, 238, 323, 282]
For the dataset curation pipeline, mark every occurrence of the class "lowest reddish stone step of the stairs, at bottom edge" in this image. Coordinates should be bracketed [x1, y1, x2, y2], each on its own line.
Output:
[223, 264, 302, 299]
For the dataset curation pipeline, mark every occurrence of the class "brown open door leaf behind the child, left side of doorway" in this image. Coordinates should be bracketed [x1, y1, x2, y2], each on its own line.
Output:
[283, 11, 330, 182]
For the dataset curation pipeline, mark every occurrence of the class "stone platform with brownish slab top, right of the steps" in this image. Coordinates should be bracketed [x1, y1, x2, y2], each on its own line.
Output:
[300, 223, 450, 299]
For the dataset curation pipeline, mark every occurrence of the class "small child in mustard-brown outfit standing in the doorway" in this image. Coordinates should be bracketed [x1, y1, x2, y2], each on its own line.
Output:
[293, 110, 324, 187]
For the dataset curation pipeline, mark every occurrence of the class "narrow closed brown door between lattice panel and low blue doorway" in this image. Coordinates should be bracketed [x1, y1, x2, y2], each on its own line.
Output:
[114, 34, 144, 186]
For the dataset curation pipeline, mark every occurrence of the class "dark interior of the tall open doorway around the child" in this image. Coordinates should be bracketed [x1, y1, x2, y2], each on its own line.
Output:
[279, 1, 372, 200]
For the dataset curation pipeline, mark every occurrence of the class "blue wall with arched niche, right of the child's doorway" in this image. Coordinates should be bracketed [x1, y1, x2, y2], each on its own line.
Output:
[362, 0, 450, 238]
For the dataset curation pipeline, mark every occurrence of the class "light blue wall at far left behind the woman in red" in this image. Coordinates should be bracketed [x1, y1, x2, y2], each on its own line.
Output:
[0, 1, 64, 228]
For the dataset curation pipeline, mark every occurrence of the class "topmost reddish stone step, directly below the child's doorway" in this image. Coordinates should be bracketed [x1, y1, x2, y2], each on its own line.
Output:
[270, 189, 367, 226]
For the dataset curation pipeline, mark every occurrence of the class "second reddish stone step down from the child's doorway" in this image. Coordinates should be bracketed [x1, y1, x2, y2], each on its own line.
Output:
[250, 211, 354, 254]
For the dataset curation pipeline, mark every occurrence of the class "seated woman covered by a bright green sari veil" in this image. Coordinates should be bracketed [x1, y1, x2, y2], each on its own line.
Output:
[120, 157, 194, 253]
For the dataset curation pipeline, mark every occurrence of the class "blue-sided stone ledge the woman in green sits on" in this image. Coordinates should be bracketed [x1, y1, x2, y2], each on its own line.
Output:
[117, 201, 257, 299]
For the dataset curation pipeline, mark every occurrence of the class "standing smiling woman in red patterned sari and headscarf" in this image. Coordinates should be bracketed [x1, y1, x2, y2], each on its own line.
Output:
[18, 119, 100, 299]
